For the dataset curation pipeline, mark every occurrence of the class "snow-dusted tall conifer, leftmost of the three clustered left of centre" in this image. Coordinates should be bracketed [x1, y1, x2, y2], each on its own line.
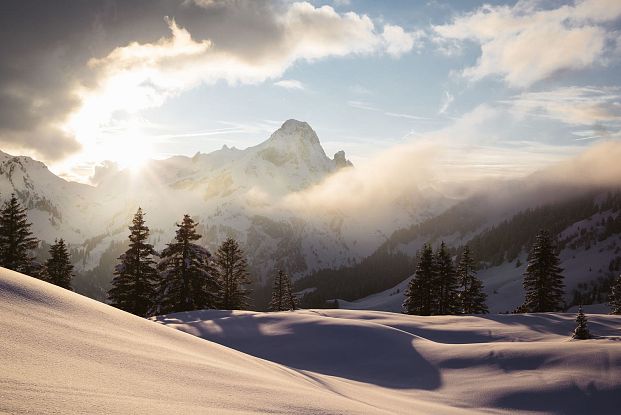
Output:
[108, 208, 158, 317]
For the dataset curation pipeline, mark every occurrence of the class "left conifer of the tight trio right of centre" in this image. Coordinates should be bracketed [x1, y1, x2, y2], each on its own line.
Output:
[403, 244, 436, 316]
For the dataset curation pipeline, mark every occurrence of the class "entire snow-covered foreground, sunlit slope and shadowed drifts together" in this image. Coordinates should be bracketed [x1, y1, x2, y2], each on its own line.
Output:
[0, 269, 621, 415]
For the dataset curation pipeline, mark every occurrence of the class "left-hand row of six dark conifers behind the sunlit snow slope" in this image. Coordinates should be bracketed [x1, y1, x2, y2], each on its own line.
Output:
[0, 195, 297, 317]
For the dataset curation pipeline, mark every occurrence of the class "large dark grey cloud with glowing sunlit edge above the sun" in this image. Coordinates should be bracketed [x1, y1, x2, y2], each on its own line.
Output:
[0, 0, 414, 166]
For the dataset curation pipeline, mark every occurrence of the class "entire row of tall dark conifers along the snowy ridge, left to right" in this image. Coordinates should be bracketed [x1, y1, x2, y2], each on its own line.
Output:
[0, 194, 621, 316]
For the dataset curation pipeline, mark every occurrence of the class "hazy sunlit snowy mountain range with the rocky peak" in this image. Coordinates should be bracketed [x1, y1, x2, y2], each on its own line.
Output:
[0, 120, 451, 298]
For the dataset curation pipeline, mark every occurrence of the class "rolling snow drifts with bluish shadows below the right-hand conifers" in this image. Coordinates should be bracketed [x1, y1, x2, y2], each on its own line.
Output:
[157, 310, 621, 414]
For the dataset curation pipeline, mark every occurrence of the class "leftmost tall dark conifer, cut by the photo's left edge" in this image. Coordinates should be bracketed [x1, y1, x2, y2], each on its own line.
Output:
[0, 194, 39, 276]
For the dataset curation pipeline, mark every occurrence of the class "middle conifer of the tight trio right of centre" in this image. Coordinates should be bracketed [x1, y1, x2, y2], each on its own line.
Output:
[432, 241, 459, 315]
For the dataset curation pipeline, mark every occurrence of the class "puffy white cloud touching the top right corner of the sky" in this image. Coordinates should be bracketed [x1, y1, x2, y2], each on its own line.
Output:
[433, 0, 621, 88]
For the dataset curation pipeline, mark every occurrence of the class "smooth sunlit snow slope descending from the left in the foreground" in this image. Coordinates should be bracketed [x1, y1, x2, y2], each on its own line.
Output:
[0, 268, 404, 414]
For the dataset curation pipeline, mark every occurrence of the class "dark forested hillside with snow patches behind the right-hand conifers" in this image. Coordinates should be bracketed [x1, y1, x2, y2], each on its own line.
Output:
[298, 188, 621, 312]
